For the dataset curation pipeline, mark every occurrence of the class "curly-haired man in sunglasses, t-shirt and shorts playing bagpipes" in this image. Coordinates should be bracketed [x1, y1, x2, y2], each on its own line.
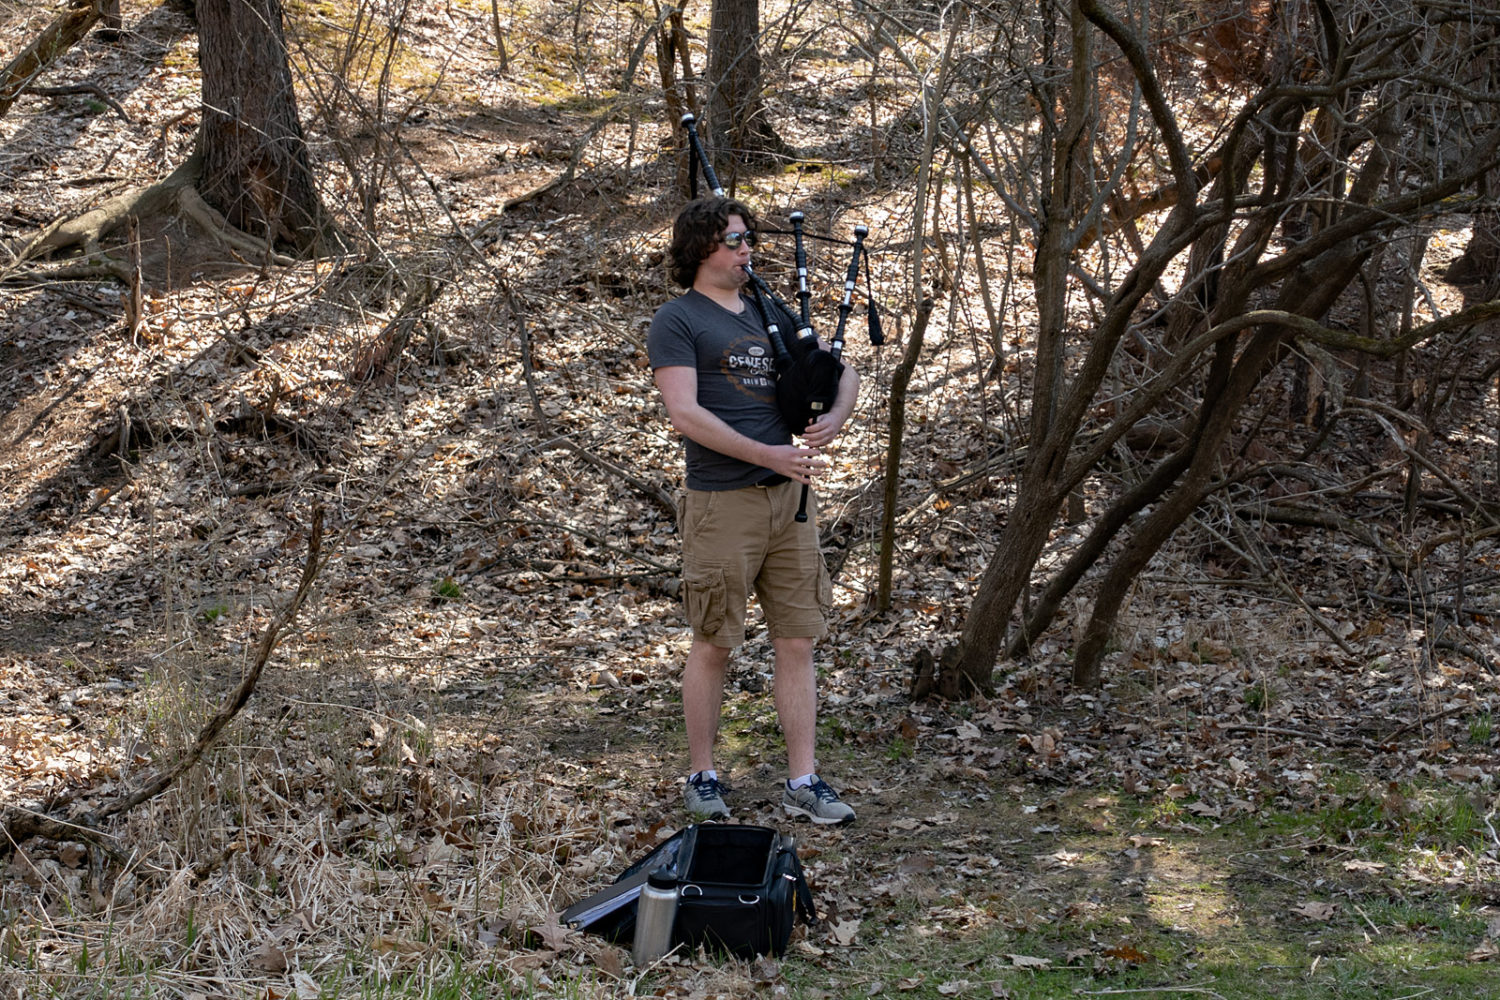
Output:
[647, 196, 860, 823]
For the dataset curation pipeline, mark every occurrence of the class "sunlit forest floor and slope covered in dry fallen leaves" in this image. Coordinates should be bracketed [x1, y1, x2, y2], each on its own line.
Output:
[0, 4, 1500, 1000]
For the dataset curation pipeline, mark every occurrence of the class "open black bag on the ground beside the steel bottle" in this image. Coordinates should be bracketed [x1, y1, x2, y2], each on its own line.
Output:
[560, 823, 818, 958]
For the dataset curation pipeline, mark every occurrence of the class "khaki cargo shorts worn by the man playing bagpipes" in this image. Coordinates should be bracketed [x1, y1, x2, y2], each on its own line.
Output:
[677, 481, 833, 649]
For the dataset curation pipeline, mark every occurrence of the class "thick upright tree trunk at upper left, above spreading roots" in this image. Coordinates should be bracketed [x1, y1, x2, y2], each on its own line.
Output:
[198, 0, 335, 256]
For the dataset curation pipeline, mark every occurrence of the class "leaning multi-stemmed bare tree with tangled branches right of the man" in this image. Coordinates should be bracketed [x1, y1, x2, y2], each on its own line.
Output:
[893, 0, 1500, 697]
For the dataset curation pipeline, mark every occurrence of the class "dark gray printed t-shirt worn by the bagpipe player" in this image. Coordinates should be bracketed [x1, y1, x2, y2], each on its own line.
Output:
[647, 289, 792, 490]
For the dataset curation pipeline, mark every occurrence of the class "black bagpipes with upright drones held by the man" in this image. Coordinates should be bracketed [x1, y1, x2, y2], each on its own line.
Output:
[683, 114, 885, 520]
